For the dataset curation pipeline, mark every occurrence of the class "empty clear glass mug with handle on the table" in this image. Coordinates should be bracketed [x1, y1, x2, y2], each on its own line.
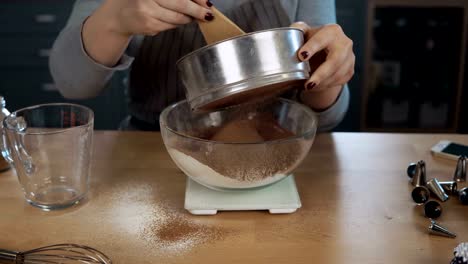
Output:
[0, 103, 94, 210]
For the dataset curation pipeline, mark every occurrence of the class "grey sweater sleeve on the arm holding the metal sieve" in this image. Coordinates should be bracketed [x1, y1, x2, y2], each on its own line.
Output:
[296, 0, 350, 131]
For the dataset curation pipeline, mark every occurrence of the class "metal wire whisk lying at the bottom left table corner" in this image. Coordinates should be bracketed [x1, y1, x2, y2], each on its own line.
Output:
[0, 244, 112, 264]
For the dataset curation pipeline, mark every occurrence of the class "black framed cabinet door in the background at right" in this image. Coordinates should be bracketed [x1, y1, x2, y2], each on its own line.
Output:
[362, 0, 468, 133]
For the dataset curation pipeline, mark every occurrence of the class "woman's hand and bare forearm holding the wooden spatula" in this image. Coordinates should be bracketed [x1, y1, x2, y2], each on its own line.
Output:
[82, 0, 214, 66]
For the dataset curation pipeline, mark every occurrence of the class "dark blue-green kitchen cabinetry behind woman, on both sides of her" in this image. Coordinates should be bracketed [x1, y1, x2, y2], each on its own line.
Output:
[0, 0, 468, 132]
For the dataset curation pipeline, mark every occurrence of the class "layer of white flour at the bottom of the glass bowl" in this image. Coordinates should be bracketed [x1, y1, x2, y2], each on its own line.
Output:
[168, 148, 286, 188]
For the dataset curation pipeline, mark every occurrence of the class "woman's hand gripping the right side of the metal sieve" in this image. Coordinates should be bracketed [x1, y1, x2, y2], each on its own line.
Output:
[292, 22, 355, 110]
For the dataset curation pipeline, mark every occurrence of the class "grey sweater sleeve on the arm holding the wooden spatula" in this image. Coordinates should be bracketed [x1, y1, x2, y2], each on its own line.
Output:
[49, 0, 133, 99]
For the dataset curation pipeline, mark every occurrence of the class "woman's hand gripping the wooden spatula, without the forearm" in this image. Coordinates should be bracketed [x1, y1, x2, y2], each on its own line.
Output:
[100, 0, 213, 36]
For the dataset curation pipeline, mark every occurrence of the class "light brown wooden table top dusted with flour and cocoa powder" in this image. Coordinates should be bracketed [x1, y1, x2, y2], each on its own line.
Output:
[0, 131, 468, 264]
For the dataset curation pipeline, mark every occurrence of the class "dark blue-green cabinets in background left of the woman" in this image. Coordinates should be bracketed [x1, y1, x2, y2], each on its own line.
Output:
[0, 0, 126, 129]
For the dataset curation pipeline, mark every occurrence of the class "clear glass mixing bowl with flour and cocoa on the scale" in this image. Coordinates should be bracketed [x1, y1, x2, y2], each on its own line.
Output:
[160, 99, 318, 190]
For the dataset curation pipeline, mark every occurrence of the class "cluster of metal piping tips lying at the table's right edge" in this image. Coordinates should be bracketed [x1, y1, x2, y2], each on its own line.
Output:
[406, 156, 468, 238]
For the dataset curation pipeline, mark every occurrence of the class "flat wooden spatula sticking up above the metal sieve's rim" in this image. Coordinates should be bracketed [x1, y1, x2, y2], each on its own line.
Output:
[198, 7, 245, 45]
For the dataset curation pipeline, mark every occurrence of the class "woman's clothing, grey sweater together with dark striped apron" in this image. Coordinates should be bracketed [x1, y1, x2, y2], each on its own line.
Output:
[49, 0, 349, 131]
